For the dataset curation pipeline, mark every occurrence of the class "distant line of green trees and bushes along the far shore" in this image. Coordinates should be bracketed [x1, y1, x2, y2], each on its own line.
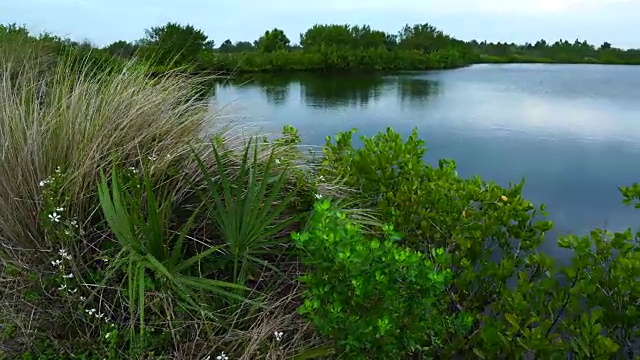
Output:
[2, 23, 640, 73]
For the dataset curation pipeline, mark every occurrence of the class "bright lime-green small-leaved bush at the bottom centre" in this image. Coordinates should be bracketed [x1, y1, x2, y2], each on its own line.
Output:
[293, 200, 472, 359]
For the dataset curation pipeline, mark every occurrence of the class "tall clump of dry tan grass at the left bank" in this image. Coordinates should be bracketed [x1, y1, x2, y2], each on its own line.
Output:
[0, 50, 213, 253]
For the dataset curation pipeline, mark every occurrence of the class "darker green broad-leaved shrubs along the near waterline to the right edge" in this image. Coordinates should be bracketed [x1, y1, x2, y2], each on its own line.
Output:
[322, 129, 640, 359]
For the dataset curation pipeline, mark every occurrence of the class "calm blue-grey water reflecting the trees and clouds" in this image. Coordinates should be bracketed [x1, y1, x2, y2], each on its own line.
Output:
[213, 65, 640, 255]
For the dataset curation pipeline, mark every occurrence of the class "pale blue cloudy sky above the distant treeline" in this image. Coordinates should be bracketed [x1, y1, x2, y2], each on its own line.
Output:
[0, 0, 640, 48]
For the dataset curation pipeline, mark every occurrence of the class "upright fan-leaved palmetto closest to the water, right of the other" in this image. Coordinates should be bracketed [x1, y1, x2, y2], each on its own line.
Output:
[195, 138, 299, 284]
